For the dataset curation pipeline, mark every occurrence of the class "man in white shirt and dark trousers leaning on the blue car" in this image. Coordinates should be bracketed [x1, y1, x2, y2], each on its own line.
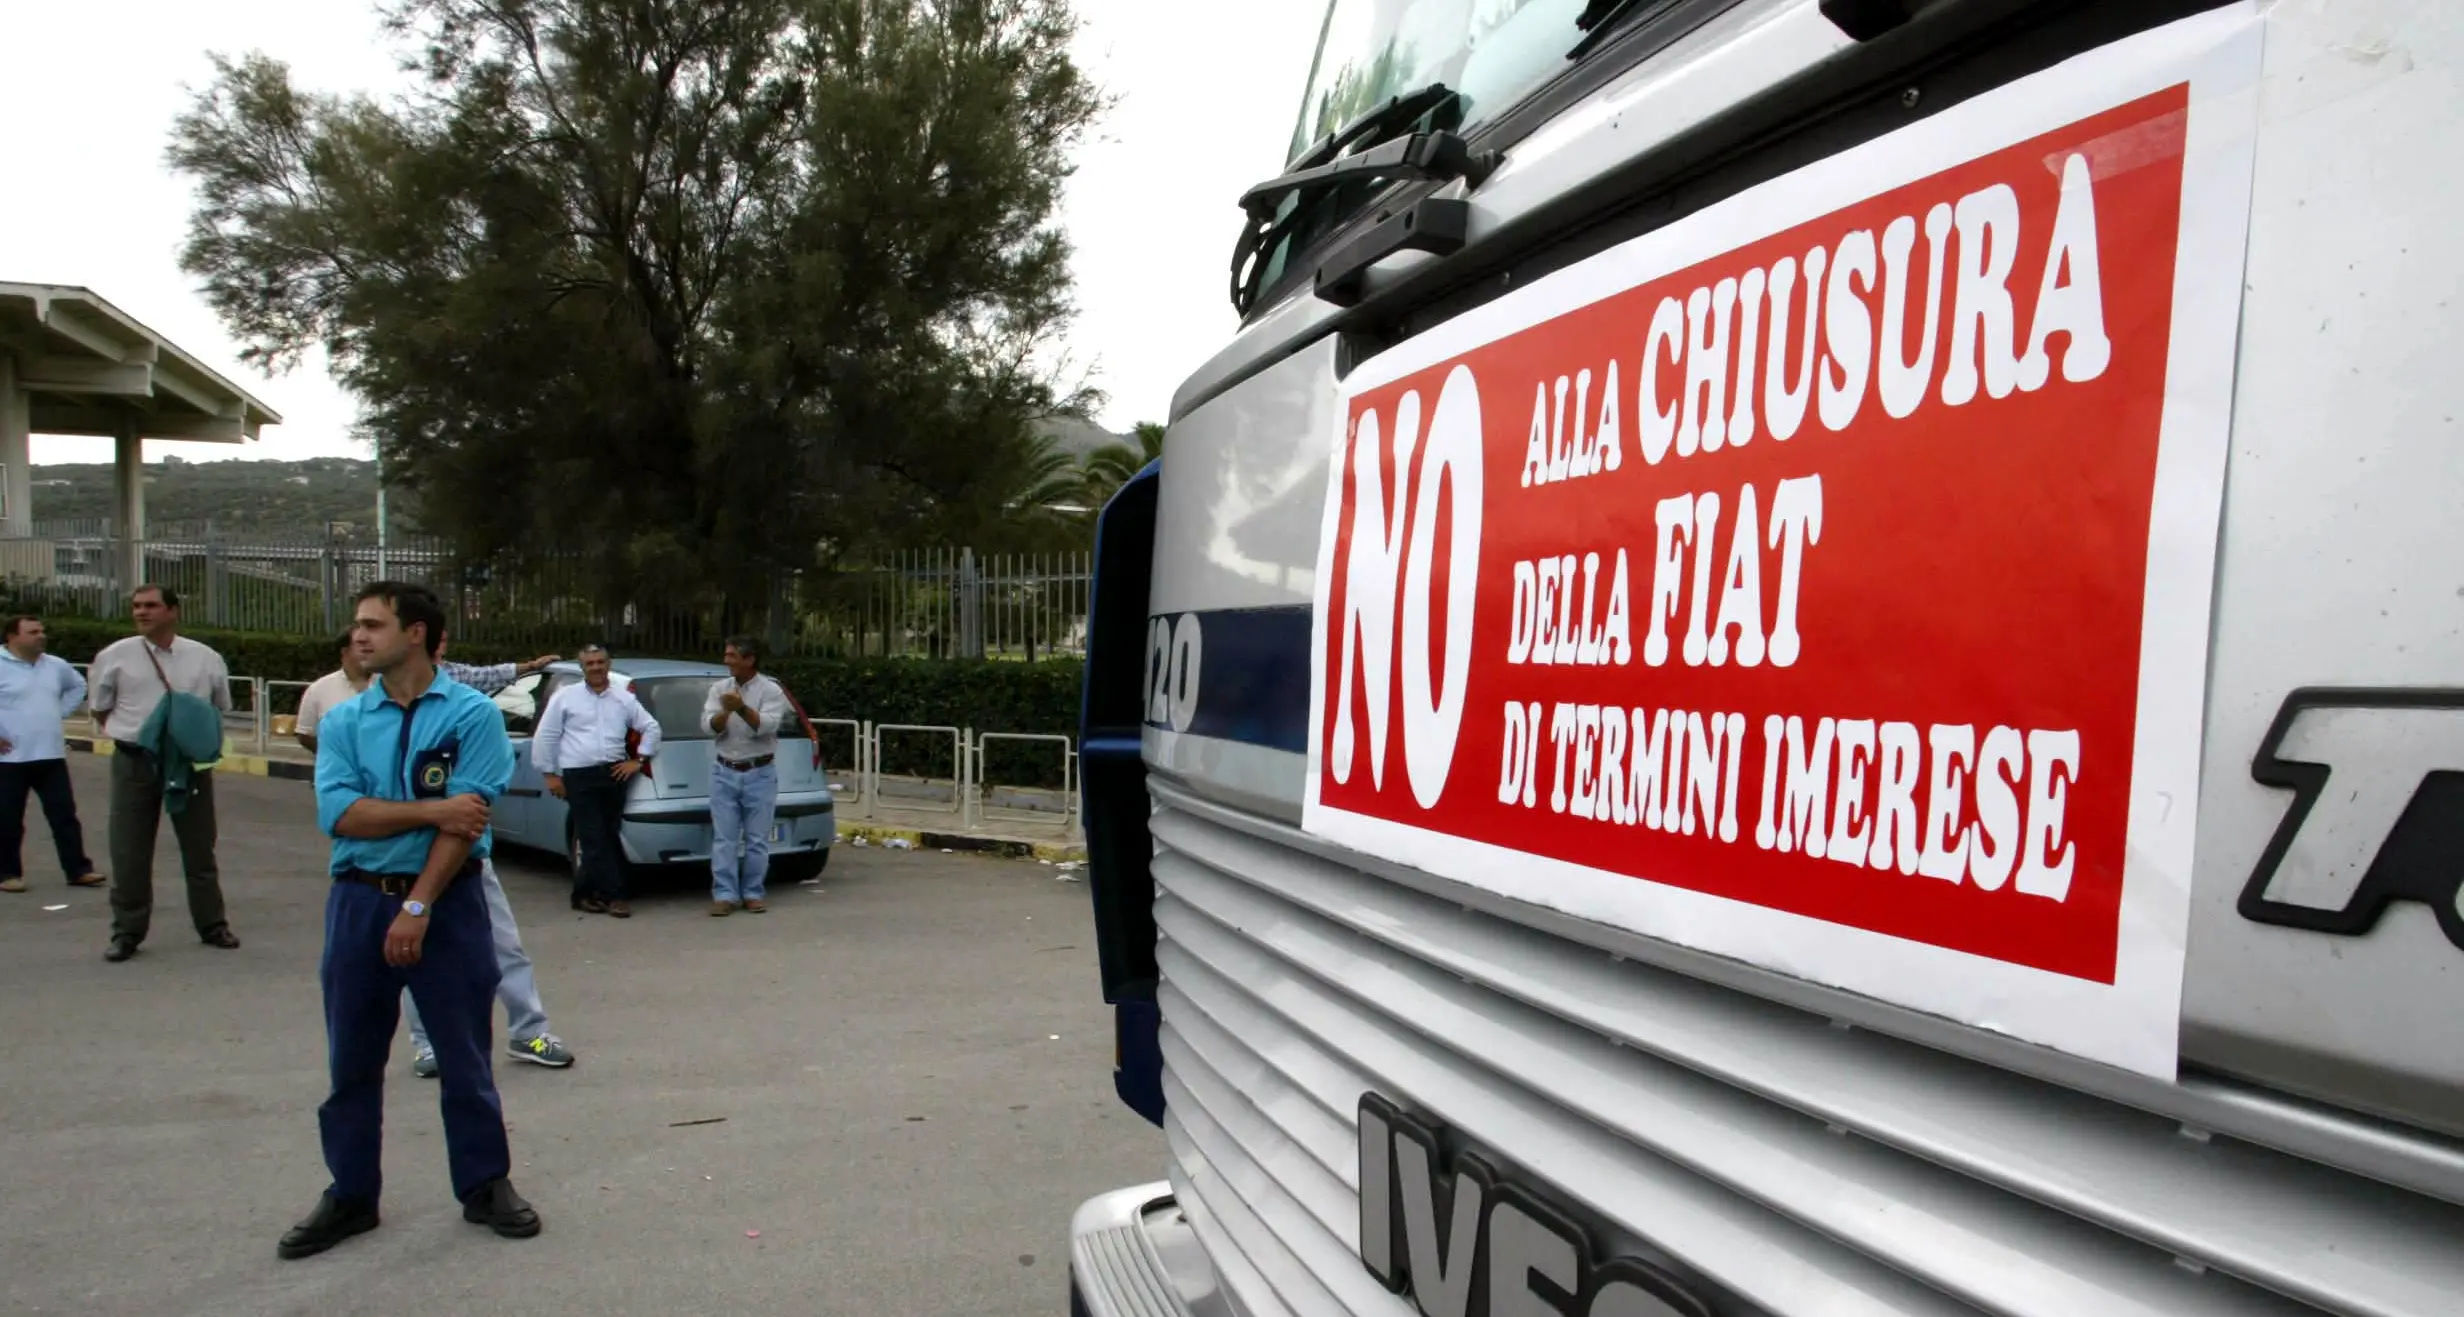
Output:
[530, 644, 658, 920]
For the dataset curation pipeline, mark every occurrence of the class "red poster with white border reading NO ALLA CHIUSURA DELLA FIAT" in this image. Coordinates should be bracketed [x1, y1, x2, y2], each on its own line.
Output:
[1303, 15, 2255, 1078]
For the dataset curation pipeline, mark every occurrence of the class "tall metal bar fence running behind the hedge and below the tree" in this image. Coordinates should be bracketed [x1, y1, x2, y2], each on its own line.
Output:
[0, 520, 1089, 661]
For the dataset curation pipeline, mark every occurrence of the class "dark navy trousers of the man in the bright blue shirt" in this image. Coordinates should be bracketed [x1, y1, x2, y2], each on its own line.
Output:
[315, 876, 513, 1206]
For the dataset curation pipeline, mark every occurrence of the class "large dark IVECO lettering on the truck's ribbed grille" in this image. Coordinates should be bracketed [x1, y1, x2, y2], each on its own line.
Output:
[1360, 1093, 1710, 1317]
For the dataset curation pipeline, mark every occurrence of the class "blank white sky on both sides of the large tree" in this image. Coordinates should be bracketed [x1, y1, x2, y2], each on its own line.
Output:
[0, 0, 1326, 464]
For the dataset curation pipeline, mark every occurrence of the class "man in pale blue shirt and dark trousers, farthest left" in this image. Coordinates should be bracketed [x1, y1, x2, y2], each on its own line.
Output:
[0, 614, 103, 893]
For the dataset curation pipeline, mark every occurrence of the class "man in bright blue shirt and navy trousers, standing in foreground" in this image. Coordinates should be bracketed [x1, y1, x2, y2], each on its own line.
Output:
[278, 582, 540, 1258]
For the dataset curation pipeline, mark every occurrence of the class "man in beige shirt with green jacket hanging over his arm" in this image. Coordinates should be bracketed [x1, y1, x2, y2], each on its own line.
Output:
[86, 585, 239, 962]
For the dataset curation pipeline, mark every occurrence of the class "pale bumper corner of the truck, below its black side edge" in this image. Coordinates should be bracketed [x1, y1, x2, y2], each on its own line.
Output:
[1069, 1181, 1232, 1317]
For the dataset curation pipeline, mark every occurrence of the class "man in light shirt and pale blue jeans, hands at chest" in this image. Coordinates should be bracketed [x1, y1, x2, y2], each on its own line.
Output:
[702, 636, 786, 915]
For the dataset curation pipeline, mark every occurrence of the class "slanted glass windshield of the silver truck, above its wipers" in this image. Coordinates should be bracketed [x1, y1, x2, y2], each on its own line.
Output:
[1284, 0, 1584, 163]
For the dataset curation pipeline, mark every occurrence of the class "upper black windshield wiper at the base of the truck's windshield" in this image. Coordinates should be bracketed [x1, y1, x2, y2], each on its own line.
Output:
[1232, 81, 1498, 313]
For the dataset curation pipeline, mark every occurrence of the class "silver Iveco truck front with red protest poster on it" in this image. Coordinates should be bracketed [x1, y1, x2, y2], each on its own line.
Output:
[1069, 0, 2464, 1317]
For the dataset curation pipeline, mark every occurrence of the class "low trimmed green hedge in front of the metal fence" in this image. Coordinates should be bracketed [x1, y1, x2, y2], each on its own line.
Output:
[26, 617, 1082, 787]
